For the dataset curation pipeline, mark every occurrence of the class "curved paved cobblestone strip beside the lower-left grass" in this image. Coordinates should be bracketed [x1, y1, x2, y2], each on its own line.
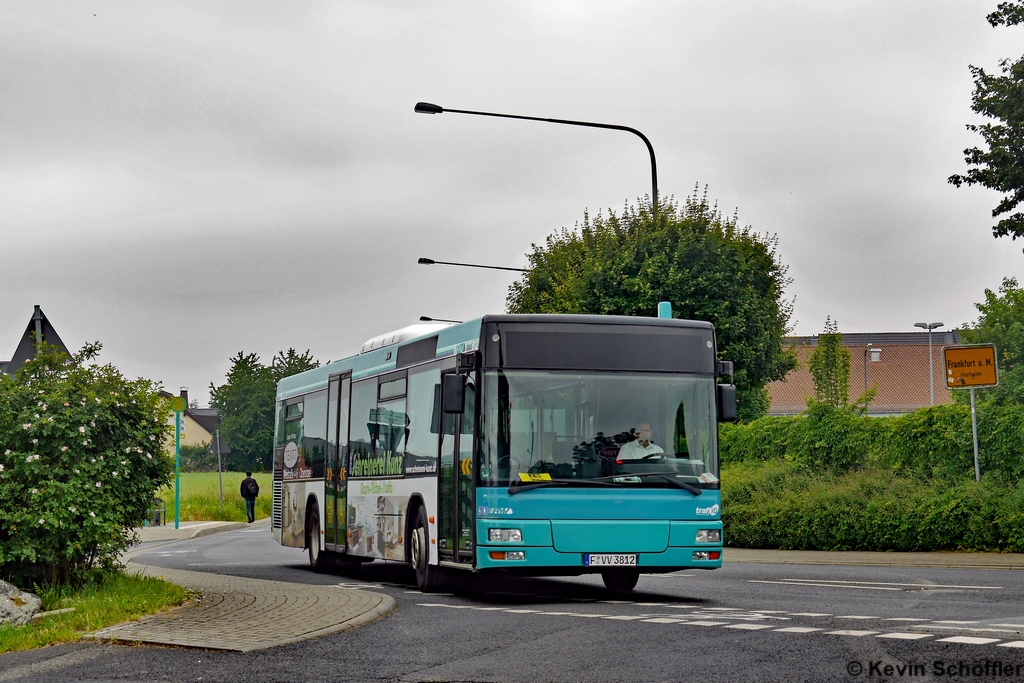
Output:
[86, 563, 395, 652]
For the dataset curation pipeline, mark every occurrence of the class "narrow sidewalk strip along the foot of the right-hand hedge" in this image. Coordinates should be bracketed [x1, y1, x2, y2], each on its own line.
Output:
[722, 548, 1024, 569]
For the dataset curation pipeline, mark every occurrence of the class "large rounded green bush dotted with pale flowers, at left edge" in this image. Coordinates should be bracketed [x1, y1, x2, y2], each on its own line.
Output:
[0, 343, 173, 585]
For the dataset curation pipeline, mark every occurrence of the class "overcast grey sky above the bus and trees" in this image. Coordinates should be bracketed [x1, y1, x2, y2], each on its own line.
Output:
[0, 0, 1024, 404]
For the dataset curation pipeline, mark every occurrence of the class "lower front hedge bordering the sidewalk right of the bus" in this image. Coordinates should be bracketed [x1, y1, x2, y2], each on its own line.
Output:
[722, 460, 1024, 552]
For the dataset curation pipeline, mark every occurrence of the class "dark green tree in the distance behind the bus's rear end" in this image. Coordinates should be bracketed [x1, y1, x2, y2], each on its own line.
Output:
[210, 348, 319, 471]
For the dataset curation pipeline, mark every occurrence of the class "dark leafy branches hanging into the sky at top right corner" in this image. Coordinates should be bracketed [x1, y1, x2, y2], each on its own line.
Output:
[949, 0, 1024, 240]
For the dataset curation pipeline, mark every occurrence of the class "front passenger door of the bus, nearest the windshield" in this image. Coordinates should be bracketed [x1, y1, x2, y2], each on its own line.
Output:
[437, 373, 476, 566]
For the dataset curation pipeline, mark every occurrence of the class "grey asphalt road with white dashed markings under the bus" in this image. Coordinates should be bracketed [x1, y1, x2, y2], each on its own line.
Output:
[0, 529, 1024, 683]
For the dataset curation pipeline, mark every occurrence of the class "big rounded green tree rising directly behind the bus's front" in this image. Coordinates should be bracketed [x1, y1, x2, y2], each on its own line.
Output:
[508, 189, 796, 418]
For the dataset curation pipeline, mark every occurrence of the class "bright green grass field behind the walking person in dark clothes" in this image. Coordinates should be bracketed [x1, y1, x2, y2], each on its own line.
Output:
[157, 472, 273, 522]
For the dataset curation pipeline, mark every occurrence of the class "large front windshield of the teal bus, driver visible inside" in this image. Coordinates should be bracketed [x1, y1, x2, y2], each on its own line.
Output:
[478, 371, 718, 488]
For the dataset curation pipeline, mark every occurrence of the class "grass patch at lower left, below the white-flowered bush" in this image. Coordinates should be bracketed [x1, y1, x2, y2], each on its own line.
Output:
[0, 572, 188, 653]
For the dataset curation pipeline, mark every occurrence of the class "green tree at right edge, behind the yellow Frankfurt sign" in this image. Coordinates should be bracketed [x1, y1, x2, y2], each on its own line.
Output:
[953, 278, 1024, 405]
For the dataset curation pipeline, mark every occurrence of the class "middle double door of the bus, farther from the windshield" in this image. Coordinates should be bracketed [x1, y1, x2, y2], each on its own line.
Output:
[324, 376, 351, 553]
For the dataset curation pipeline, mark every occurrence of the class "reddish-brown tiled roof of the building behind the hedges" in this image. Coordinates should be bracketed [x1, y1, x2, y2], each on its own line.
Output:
[768, 331, 961, 416]
